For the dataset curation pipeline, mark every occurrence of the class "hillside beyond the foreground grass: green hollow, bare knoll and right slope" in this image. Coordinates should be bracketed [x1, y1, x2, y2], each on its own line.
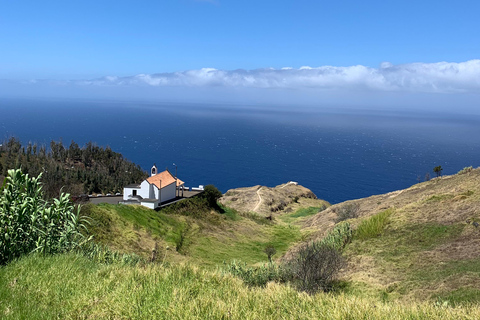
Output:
[79, 169, 480, 303]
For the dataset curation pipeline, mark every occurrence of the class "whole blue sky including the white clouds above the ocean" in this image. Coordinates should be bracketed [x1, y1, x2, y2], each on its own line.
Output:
[0, 0, 480, 108]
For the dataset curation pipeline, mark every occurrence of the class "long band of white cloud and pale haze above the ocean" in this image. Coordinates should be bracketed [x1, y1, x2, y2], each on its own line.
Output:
[0, 60, 480, 114]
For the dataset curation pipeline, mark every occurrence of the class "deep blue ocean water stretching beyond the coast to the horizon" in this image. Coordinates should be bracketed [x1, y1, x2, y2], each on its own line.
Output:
[0, 99, 480, 203]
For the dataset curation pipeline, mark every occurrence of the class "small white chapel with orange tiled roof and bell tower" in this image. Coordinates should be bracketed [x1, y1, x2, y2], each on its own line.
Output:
[123, 165, 184, 209]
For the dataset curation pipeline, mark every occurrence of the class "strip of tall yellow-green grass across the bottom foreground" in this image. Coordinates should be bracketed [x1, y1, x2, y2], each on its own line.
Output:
[0, 254, 480, 320]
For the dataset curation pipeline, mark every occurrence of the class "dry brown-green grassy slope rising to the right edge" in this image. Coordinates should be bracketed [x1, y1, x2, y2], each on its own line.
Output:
[302, 169, 480, 304]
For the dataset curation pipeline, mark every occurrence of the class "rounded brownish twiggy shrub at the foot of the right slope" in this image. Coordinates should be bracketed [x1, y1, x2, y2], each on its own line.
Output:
[286, 242, 346, 294]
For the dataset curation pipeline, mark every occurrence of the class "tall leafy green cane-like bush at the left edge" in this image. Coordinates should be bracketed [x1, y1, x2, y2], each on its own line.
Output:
[0, 169, 90, 265]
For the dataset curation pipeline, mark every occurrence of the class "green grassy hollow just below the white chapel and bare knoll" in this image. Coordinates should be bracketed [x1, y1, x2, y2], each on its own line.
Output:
[83, 200, 323, 267]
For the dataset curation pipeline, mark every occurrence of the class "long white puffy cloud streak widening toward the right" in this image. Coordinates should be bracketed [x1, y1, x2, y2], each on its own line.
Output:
[75, 60, 480, 93]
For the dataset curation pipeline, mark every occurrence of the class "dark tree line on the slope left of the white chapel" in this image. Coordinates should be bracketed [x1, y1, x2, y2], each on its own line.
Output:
[0, 137, 147, 198]
